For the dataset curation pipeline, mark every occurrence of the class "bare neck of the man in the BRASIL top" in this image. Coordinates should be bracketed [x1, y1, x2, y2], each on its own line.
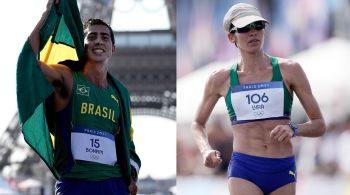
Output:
[83, 62, 108, 88]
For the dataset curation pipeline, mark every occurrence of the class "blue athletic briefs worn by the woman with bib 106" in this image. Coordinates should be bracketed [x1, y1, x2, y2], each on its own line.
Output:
[228, 152, 296, 194]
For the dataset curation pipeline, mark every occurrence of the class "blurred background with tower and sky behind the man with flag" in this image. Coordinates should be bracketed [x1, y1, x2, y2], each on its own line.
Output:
[0, 0, 176, 195]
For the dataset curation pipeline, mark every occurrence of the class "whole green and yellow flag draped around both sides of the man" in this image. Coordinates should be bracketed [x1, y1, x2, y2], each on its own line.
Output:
[17, 0, 141, 183]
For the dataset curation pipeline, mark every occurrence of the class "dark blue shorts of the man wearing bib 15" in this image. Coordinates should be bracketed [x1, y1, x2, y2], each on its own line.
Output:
[55, 178, 129, 195]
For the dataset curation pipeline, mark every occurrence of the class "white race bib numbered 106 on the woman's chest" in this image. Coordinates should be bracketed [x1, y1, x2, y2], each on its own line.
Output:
[231, 81, 284, 121]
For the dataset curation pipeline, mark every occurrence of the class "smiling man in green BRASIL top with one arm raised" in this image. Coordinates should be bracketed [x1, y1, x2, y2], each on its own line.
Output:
[25, 0, 141, 195]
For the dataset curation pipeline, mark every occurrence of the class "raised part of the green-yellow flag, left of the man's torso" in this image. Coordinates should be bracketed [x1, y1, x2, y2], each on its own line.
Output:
[17, 0, 84, 178]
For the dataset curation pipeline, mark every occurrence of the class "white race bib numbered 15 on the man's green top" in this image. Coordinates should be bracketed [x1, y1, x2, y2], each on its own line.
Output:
[71, 128, 117, 166]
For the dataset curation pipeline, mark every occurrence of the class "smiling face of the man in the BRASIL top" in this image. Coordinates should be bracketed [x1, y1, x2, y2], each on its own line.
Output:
[84, 25, 115, 62]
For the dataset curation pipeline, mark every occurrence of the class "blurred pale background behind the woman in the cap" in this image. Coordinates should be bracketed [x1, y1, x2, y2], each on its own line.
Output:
[176, 0, 350, 195]
